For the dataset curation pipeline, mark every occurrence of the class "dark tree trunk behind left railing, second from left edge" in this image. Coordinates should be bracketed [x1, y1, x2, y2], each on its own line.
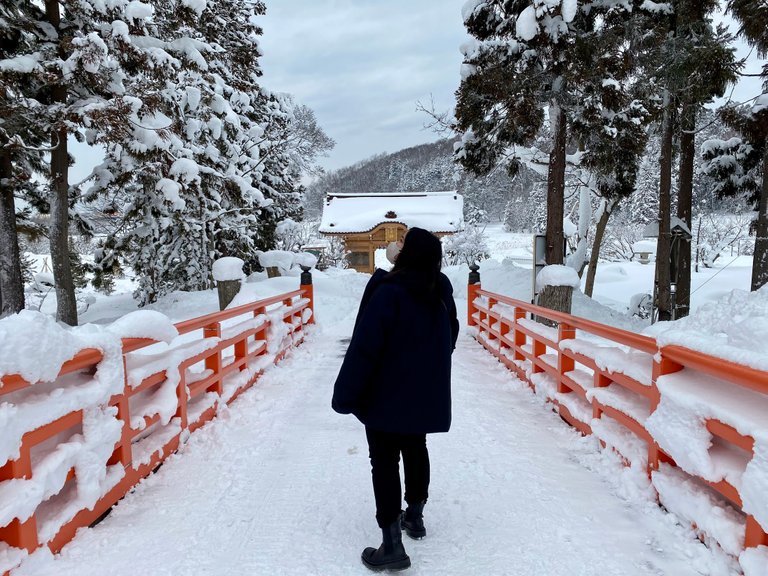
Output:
[45, 0, 77, 326]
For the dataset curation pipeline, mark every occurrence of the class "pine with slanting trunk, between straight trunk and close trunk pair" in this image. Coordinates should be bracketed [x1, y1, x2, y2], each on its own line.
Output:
[569, 4, 656, 296]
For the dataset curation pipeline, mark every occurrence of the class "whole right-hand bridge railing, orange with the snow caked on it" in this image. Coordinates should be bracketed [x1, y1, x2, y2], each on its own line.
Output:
[467, 270, 768, 575]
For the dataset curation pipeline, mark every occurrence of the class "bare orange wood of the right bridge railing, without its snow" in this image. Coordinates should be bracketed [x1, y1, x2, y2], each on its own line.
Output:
[467, 270, 768, 560]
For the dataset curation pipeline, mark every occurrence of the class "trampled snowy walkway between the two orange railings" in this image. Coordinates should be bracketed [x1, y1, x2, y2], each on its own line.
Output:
[14, 276, 728, 576]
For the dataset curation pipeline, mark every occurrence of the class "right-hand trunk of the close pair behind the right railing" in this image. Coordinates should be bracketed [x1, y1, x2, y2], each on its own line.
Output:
[672, 103, 697, 319]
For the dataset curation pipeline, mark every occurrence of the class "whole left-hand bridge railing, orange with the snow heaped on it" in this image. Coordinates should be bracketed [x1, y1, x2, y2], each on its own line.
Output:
[0, 282, 314, 575]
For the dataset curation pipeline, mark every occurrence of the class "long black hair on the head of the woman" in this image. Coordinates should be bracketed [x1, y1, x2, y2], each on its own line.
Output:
[389, 228, 443, 296]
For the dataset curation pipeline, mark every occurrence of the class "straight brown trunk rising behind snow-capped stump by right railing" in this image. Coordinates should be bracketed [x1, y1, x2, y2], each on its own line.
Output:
[545, 98, 566, 265]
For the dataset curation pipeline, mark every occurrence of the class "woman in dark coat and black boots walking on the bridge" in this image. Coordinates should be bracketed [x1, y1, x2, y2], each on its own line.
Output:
[332, 228, 459, 570]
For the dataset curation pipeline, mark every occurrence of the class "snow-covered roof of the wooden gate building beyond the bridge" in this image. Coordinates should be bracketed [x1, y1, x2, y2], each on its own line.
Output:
[320, 191, 464, 234]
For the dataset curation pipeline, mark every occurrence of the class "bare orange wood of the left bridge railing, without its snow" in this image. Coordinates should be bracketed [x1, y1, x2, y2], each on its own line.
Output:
[0, 282, 314, 576]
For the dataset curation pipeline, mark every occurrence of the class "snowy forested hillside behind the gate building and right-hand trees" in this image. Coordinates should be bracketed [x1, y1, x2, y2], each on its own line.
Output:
[305, 109, 746, 231]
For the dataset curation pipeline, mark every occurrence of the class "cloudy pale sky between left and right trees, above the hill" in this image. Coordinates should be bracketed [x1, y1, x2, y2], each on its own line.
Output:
[259, 0, 467, 169]
